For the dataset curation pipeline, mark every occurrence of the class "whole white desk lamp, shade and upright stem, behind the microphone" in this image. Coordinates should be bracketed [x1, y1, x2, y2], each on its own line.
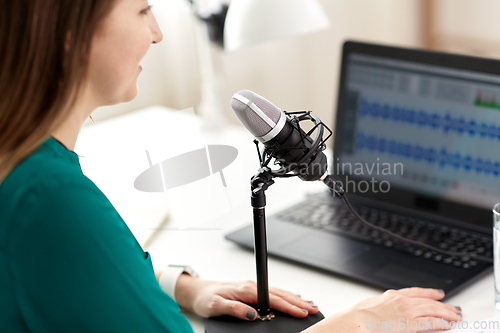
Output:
[190, 0, 330, 130]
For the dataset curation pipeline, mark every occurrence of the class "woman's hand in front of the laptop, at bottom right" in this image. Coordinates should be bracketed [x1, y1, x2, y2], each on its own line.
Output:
[304, 288, 462, 333]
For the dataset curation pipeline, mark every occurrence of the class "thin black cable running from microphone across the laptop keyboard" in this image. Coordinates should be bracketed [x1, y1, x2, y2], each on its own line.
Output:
[323, 176, 493, 263]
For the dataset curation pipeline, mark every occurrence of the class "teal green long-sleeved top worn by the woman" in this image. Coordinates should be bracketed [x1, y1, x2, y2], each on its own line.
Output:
[0, 137, 192, 333]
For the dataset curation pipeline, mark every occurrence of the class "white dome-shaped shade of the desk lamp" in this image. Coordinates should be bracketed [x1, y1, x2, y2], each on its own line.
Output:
[224, 0, 330, 52]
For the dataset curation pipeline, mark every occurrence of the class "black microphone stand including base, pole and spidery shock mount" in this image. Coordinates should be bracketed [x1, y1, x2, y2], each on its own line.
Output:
[205, 111, 326, 333]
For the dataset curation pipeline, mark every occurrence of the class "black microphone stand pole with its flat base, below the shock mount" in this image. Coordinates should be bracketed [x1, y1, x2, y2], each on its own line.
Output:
[205, 167, 324, 333]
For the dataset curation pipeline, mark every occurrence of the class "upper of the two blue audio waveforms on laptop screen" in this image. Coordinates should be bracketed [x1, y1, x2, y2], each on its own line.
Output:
[358, 99, 500, 140]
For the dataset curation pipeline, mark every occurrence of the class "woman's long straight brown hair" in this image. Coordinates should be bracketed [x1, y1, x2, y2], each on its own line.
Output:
[0, 0, 115, 184]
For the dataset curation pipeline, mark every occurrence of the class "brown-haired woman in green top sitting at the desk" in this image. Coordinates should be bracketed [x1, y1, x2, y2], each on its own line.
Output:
[0, 0, 461, 333]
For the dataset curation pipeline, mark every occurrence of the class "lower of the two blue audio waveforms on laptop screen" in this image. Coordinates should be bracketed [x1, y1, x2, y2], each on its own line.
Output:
[356, 132, 500, 177]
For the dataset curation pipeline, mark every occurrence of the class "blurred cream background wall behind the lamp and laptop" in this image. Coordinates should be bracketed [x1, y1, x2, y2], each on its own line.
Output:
[92, 0, 500, 132]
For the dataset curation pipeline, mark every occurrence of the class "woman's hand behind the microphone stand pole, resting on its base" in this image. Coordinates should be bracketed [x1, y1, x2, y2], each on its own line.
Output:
[175, 274, 318, 320]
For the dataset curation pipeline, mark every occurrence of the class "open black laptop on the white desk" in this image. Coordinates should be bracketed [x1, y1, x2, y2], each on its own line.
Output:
[226, 41, 500, 297]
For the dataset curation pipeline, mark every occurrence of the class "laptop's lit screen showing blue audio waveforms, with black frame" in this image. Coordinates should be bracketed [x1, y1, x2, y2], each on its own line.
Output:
[331, 42, 500, 232]
